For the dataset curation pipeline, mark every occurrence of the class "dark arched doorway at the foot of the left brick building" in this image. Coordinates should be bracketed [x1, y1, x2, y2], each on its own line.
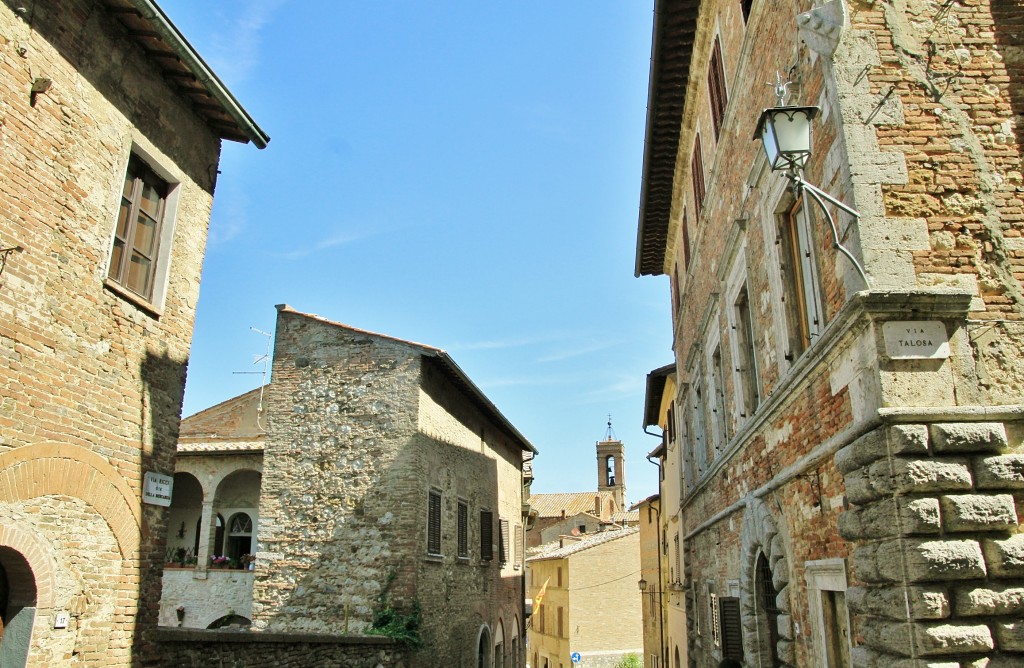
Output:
[0, 546, 37, 668]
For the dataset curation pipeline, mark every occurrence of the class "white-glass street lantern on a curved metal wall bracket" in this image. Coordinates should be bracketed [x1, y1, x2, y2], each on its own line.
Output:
[754, 75, 871, 287]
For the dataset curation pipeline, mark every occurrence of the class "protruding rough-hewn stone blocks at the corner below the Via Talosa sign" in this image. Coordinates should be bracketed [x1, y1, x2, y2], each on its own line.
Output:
[837, 421, 1024, 668]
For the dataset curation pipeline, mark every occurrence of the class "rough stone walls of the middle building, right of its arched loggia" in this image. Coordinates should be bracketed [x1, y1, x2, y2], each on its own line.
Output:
[253, 306, 523, 666]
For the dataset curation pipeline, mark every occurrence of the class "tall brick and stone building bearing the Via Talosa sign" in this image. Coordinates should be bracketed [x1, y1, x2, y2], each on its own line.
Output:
[636, 0, 1024, 668]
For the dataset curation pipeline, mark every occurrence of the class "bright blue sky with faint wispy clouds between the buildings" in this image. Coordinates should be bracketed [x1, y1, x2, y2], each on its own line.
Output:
[167, 0, 672, 501]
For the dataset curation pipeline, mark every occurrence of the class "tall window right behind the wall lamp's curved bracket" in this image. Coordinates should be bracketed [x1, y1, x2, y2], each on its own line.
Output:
[779, 196, 824, 362]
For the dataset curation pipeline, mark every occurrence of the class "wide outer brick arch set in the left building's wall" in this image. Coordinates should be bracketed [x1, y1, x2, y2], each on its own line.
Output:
[0, 443, 142, 559]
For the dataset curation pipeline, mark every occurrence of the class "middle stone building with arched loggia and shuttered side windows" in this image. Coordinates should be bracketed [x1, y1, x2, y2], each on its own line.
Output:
[161, 305, 536, 666]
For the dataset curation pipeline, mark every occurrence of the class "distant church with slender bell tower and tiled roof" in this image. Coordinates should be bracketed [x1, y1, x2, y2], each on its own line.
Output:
[526, 422, 636, 547]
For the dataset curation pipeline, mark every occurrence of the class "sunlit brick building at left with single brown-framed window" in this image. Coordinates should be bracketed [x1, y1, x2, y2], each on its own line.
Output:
[0, 0, 268, 667]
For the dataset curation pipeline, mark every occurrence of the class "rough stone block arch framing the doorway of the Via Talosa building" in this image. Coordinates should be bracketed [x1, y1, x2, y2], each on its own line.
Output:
[739, 498, 796, 666]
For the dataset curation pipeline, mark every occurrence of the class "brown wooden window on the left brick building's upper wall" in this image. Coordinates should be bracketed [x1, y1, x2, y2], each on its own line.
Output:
[106, 155, 170, 301]
